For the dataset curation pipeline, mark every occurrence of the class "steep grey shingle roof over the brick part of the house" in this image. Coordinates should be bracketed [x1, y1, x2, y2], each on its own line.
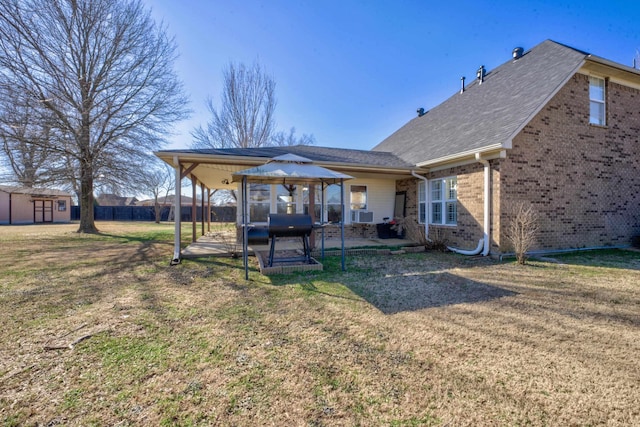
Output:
[373, 40, 588, 164]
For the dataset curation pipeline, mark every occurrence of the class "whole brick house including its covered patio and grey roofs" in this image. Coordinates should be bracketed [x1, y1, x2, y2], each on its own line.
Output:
[156, 40, 640, 255]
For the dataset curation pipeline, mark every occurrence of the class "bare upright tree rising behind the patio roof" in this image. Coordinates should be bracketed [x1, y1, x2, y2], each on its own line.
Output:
[192, 63, 276, 148]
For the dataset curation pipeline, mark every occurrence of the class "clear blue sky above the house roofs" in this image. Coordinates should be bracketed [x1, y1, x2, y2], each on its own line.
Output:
[148, 0, 640, 150]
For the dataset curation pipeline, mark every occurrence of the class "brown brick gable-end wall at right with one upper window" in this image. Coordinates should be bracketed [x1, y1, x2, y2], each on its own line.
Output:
[498, 74, 640, 250]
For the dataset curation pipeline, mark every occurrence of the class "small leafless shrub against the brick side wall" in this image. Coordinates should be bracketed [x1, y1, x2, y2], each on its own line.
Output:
[506, 202, 539, 265]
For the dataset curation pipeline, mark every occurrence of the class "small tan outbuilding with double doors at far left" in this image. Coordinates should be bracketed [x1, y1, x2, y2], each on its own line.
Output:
[0, 185, 71, 224]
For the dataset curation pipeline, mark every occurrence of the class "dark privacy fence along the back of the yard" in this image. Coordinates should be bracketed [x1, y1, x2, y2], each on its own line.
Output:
[71, 206, 236, 222]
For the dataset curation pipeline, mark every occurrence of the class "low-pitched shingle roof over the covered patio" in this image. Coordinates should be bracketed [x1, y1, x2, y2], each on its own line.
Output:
[158, 145, 413, 169]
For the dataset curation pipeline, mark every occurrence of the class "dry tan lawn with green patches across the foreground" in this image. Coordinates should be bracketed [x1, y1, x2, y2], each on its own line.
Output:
[0, 223, 640, 426]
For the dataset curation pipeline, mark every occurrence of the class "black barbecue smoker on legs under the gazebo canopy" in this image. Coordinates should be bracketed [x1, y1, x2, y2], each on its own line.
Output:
[268, 214, 313, 267]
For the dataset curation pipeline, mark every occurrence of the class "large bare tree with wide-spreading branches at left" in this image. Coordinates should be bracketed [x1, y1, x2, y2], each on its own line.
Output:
[0, 0, 188, 233]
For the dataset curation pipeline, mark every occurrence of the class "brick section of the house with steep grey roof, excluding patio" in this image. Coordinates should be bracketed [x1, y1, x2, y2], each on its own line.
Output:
[374, 40, 640, 254]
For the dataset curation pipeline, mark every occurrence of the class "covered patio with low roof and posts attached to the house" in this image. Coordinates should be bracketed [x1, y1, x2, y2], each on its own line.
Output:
[155, 146, 420, 274]
